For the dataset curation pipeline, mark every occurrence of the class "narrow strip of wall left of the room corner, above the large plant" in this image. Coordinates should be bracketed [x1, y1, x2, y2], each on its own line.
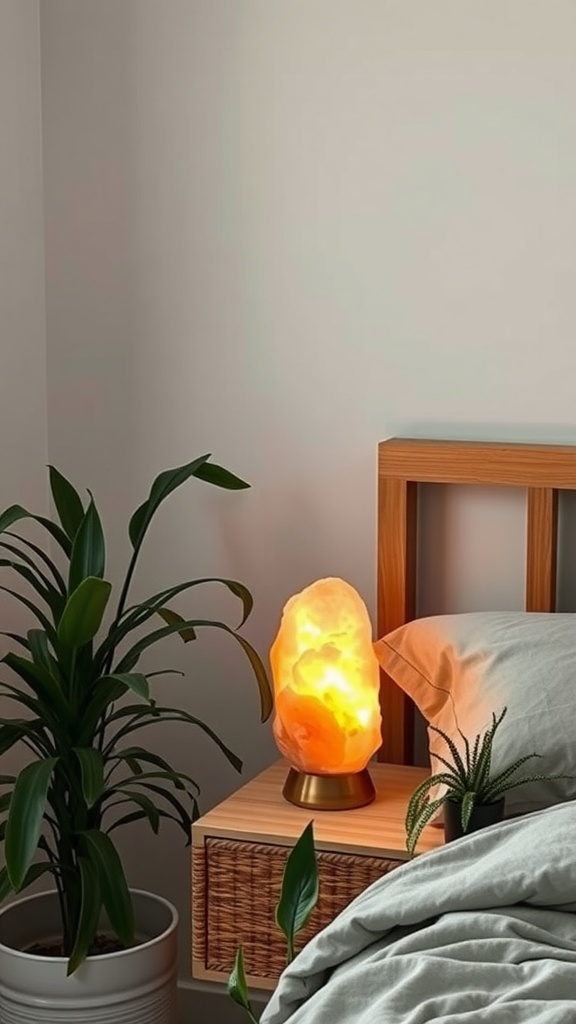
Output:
[0, 0, 47, 512]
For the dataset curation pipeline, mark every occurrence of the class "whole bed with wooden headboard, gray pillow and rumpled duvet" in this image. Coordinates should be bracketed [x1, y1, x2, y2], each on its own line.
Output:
[261, 438, 576, 1024]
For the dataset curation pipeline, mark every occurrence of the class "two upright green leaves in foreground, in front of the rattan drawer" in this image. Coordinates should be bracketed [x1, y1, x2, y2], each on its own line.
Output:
[228, 821, 319, 1024]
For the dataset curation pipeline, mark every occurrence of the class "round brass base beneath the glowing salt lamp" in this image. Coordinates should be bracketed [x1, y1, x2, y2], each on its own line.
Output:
[282, 768, 376, 811]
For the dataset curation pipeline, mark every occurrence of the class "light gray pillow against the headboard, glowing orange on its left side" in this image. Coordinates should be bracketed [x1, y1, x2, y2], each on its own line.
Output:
[375, 611, 576, 816]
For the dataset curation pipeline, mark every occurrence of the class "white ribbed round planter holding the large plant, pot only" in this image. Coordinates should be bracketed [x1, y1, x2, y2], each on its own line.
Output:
[0, 890, 178, 1024]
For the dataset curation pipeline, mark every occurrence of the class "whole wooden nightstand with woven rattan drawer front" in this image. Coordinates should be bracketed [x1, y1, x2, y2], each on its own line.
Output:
[192, 761, 436, 989]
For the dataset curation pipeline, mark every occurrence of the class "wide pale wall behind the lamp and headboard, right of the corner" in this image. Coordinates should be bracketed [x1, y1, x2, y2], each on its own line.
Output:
[40, 0, 576, 991]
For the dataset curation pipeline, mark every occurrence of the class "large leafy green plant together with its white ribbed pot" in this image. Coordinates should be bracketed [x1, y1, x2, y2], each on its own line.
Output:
[0, 456, 272, 1024]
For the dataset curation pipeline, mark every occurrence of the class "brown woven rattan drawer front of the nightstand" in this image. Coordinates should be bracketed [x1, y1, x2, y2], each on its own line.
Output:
[193, 839, 402, 979]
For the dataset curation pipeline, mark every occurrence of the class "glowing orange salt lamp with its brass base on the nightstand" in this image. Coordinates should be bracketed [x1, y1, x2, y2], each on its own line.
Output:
[271, 579, 380, 810]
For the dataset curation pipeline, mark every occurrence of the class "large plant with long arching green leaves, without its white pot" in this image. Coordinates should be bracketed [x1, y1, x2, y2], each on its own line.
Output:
[0, 456, 272, 973]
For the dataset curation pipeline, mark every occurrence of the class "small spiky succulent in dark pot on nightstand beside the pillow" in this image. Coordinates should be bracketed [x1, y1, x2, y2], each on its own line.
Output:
[406, 708, 563, 856]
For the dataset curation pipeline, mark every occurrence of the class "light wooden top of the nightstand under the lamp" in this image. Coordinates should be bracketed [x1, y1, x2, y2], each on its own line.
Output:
[193, 761, 444, 860]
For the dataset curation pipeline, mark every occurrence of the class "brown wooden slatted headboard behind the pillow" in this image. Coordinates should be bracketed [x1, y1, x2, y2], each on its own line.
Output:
[377, 437, 576, 764]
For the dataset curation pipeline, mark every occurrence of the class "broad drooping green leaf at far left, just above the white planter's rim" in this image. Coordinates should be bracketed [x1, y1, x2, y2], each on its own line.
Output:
[4, 758, 57, 892]
